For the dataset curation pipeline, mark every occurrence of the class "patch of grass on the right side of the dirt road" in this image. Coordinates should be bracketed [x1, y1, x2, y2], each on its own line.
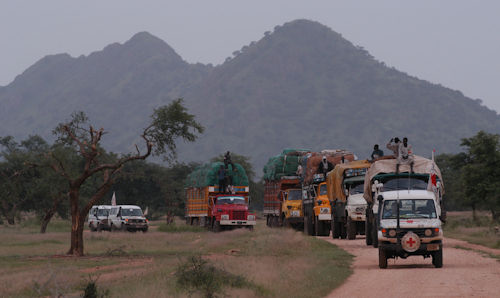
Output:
[443, 211, 500, 249]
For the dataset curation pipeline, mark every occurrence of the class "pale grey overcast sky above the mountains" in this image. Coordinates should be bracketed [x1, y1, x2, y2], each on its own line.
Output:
[0, 0, 500, 112]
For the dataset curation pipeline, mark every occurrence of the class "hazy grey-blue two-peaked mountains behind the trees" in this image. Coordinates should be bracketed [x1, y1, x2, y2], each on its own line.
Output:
[0, 20, 500, 171]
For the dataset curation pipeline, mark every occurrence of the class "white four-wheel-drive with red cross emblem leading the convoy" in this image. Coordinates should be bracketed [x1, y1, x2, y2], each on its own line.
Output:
[377, 190, 443, 268]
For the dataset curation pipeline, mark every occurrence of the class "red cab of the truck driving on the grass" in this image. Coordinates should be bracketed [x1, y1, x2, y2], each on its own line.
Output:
[211, 194, 256, 232]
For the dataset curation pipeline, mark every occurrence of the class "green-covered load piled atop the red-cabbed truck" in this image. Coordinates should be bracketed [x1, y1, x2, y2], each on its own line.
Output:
[185, 161, 248, 187]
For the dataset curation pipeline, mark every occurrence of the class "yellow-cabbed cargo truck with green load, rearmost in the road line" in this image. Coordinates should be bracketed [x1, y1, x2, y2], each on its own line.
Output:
[264, 149, 309, 229]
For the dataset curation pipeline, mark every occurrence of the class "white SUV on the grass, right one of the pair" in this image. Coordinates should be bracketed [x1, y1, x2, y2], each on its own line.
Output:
[109, 205, 148, 232]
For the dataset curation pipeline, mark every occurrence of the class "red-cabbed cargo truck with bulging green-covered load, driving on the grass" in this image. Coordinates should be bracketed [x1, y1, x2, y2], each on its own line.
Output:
[186, 162, 256, 232]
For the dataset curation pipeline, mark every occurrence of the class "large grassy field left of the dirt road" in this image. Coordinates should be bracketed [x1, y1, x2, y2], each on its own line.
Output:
[0, 220, 352, 297]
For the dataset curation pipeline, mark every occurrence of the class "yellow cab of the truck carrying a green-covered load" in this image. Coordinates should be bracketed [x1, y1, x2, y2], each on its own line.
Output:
[279, 188, 304, 227]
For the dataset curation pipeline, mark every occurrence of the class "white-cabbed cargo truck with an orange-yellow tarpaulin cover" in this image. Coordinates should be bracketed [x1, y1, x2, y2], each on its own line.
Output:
[327, 160, 371, 239]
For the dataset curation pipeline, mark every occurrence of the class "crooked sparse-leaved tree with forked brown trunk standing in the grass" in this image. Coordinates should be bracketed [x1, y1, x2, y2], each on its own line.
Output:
[47, 99, 203, 256]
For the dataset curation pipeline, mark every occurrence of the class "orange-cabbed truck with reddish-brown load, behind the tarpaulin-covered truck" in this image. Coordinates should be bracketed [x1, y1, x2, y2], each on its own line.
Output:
[302, 150, 355, 236]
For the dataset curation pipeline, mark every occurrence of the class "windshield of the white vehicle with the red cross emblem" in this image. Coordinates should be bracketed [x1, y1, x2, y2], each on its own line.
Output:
[382, 200, 436, 219]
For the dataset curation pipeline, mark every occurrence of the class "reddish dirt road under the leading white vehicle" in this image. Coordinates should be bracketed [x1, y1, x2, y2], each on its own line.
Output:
[318, 237, 500, 297]
